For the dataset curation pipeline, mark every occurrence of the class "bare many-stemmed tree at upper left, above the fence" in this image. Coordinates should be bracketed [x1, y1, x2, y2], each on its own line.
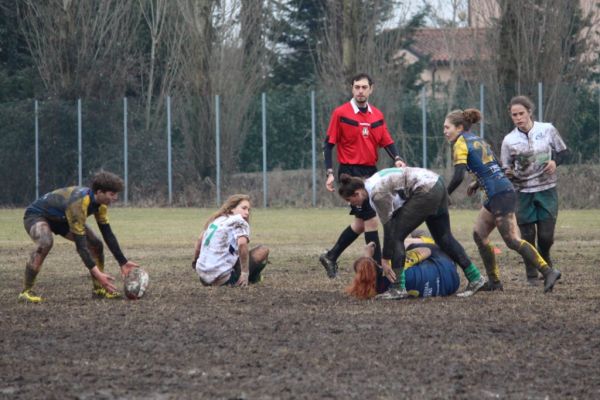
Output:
[18, 0, 139, 98]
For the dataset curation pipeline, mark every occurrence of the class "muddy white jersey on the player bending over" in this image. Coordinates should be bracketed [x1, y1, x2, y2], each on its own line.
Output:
[365, 167, 440, 224]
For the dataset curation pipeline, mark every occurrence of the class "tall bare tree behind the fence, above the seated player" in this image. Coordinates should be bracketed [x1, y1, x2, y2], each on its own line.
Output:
[173, 0, 270, 183]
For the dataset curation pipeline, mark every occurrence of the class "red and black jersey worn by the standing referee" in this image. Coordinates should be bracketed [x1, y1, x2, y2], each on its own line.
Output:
[327, 99, 394, 166]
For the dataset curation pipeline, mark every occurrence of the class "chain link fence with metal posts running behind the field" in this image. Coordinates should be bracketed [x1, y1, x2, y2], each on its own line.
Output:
[0, 84, 600, 207]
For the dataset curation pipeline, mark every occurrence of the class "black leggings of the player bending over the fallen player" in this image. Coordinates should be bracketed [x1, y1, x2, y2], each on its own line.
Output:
[384, 180, 471, 271]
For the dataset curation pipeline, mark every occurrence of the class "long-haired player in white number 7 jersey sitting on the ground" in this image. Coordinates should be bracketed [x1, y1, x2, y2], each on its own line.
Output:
[192, 194, 269, 286]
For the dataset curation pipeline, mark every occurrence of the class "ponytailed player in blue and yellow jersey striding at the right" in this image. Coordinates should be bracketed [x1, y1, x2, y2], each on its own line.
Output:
[444, 108, 561, 292]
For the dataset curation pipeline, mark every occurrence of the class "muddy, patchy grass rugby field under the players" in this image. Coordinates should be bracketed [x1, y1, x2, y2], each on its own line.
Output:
[0, 208, 600, 399]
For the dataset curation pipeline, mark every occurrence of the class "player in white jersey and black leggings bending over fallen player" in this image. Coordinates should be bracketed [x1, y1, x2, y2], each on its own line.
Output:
[338, 167, 485, 300]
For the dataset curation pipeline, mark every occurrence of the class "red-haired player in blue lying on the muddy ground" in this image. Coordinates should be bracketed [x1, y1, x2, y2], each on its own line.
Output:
[346, 237, 460, 299]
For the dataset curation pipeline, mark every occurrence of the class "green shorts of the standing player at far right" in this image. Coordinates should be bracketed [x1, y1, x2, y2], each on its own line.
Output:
[517, 187, 558, 225]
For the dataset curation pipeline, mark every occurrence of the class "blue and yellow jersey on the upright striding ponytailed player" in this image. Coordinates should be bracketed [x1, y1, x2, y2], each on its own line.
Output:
[452, 132, 514, 199]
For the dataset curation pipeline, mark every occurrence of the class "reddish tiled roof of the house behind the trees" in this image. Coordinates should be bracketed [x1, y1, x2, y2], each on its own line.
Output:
[408, 28, 491, 64]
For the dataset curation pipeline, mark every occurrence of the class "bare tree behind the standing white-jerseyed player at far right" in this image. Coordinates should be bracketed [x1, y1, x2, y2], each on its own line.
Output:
[468, 0, 600, 148]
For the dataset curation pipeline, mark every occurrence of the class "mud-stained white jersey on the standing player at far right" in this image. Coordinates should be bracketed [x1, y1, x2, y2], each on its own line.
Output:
[500, 121, 567, 193]
